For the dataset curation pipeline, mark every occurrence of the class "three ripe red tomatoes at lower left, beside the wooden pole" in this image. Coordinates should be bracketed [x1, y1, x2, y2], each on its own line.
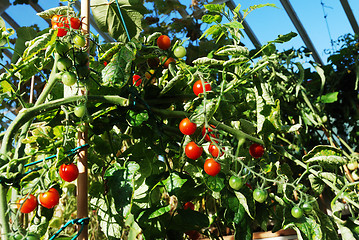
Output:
[16, 163, 79, 213]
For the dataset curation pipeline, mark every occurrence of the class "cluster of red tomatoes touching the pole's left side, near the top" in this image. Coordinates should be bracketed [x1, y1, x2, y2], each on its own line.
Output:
[51, 15, 82, 37]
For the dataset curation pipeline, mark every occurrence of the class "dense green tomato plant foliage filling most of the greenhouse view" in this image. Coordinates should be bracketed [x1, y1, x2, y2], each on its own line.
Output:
[0, 1, 359, 239]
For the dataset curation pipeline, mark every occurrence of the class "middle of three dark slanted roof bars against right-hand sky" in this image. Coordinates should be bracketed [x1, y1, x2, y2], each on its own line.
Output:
[280, 0, 323, 65]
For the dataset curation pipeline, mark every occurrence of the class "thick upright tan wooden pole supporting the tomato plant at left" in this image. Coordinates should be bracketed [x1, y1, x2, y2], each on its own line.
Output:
[77, 0, 90, 240]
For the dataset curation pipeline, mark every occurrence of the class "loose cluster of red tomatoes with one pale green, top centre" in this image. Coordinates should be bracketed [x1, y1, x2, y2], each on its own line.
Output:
[132, 35, 187, 87]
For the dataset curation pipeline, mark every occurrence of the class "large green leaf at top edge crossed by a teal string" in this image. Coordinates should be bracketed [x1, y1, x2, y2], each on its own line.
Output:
[91, 0, 147, 42]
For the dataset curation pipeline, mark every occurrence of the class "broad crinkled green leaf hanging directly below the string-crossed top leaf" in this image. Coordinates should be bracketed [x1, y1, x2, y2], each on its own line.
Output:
[102, 44, 137, 88]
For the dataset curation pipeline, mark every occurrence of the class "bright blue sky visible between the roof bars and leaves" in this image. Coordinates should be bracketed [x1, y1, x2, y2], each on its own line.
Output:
[2, 0, 359, 62]
